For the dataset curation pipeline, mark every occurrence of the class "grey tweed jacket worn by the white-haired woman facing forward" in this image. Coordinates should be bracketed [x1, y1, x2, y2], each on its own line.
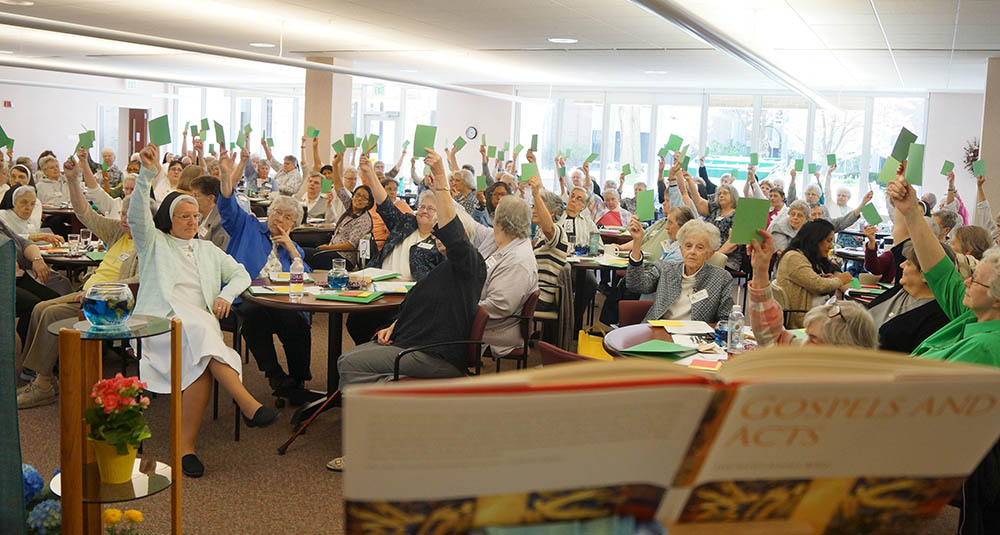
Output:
[625, 257, 733, 323]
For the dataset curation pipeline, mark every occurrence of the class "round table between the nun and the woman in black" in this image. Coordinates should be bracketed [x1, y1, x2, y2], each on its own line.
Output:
[242, 280, 406, 426]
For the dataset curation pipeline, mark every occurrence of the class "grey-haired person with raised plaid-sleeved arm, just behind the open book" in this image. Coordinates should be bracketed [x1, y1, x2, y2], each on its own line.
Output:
[747, 230, 878, 349]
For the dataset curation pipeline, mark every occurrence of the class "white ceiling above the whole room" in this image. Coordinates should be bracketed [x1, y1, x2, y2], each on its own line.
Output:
[0, 0, 1000, 91]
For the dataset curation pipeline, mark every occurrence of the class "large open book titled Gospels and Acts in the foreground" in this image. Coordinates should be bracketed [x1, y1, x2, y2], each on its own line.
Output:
[343, 346, 1000, 534]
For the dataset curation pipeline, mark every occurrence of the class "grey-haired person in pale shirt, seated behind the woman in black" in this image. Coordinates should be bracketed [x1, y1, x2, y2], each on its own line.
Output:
[479, 195, 541, 356]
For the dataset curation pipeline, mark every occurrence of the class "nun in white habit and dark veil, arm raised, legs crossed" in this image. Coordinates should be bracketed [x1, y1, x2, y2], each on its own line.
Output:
[128, 144, 277, 477]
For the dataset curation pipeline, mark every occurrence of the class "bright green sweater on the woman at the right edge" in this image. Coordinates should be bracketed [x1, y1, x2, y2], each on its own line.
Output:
[913, 256, 1000, 367]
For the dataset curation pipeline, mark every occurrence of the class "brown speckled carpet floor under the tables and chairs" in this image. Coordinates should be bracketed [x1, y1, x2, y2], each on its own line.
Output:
[19, 304, 957, 535]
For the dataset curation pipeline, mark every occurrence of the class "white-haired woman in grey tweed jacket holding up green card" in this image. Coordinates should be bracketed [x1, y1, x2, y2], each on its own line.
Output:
[625, 220, 733, 323]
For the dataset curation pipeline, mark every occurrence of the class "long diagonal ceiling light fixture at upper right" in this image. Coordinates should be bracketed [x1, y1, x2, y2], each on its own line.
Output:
[631, 0, 837, 110]
